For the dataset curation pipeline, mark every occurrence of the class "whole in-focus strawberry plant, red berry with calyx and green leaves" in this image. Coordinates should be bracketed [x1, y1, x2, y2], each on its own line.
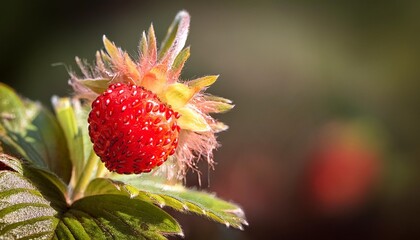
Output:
[0, 11, 247, 239]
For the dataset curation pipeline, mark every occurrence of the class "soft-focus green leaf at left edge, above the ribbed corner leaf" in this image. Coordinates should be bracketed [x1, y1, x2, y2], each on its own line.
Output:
[0, 83, 71, 182]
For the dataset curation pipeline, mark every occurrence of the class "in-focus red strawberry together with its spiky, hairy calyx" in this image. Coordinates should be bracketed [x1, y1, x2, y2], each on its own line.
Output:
[70, 11, 233, 180]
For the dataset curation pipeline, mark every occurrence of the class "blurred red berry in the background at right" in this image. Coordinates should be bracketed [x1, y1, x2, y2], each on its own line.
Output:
[308, 124, 382, 213]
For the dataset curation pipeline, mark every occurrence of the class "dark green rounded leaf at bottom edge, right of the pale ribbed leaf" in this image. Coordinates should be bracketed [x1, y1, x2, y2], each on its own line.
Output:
[56, 194, 182, 239]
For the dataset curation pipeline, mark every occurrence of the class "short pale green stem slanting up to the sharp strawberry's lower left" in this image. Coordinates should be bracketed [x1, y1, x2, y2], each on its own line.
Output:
[72, 150, 100, 201]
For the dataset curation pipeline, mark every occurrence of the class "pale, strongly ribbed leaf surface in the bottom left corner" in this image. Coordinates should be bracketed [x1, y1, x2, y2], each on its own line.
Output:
[0, 171, 58, 239]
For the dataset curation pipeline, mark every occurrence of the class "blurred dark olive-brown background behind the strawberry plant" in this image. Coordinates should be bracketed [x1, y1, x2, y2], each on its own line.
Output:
[0, 0, 420, 239]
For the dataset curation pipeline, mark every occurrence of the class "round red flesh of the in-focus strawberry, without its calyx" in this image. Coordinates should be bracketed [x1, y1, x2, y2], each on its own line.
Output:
[88, 83, 180, 174]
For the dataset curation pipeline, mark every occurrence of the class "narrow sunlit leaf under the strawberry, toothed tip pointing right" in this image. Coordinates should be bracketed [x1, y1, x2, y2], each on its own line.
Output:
[85, 176, 248, 229]
